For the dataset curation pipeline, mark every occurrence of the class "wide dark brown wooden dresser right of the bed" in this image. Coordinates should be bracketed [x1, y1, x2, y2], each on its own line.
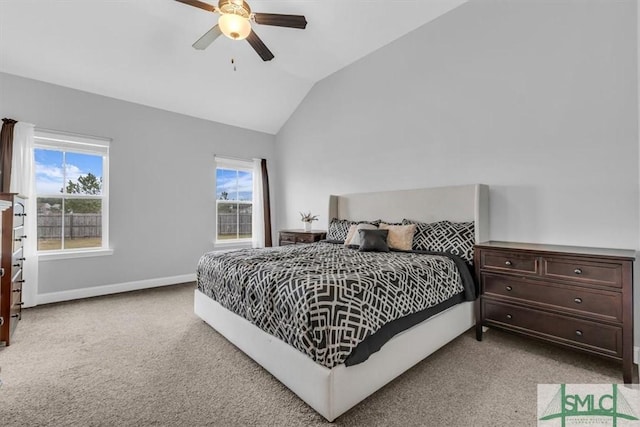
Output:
[474, 242, 637, 384]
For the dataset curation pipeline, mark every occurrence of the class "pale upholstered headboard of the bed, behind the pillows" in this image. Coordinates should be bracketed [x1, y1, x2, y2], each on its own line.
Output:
[328, 184, 489, 243]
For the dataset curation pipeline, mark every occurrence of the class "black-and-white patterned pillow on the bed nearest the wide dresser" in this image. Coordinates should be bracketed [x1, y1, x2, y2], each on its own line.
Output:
[402, 219, 475, 264]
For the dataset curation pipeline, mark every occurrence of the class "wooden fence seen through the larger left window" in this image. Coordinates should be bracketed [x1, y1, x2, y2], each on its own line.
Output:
[38, 213, 102, 239]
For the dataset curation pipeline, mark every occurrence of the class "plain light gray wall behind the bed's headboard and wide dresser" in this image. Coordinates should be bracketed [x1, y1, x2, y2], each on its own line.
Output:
[276, 0, 640, 254]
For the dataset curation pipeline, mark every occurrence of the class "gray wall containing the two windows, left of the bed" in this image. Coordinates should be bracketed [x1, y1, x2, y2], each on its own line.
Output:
[0, 73, 275, 294]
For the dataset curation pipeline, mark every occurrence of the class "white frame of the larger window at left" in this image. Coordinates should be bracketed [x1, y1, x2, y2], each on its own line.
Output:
[33, 129, 113, 261]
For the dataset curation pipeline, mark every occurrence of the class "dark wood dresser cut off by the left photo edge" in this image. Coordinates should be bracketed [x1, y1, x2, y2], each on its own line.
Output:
[0, 193, 27, 346]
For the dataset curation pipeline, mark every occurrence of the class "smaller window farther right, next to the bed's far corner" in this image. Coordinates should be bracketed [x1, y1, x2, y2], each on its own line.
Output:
[216, 157, 253, 243]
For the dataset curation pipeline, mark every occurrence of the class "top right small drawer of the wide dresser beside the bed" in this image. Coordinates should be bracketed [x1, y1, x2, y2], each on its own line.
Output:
[544, 257, 622, 288]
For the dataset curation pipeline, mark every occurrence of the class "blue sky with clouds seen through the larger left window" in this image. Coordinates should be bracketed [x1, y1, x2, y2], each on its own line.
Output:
[34, 148, 102, 194]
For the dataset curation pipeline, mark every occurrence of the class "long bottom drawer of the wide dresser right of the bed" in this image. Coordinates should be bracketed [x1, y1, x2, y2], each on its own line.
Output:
[482, 300, 622, 357]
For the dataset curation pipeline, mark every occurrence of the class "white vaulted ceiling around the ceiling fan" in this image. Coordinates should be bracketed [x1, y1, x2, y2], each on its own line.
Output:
[0, 0, 467, 134]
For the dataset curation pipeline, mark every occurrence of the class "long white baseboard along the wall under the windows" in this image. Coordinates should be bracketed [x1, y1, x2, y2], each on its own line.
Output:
[36, 273, 196, 305]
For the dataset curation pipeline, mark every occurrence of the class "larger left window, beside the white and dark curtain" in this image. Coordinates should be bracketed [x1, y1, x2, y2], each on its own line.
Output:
[34, 130, 109, 254]
